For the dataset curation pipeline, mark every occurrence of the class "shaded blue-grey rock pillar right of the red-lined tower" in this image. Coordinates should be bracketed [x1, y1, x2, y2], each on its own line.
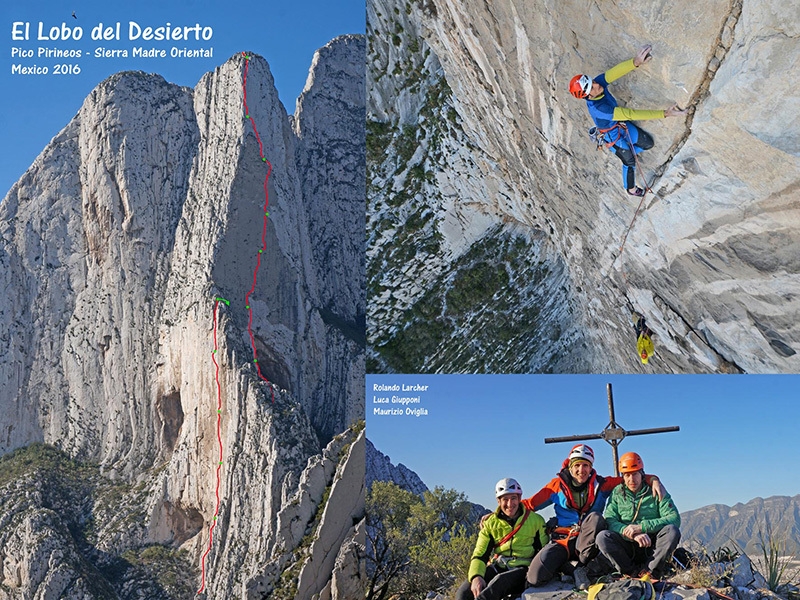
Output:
[293, 35, 366, 437]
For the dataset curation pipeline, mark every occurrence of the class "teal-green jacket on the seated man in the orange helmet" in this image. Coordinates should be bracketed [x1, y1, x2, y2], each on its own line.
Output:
[603, 482, 681, 534]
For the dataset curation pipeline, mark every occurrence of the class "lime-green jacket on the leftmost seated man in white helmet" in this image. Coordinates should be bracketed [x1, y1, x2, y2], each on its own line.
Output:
[468, 505, 550, 581]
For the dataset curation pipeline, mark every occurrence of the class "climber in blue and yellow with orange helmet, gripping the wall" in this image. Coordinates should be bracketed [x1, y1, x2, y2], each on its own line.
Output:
[569, 45, 687, 196]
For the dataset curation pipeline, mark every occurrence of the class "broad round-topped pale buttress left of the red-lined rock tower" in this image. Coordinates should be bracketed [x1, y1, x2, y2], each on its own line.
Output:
[0, 73, 198, 468]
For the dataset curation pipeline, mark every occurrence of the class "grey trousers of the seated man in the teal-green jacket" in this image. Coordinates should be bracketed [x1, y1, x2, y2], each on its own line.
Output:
[597, 525, 681, 575]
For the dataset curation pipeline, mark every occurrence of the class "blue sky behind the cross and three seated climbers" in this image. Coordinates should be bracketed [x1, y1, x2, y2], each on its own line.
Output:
[367, 375, 800, 511]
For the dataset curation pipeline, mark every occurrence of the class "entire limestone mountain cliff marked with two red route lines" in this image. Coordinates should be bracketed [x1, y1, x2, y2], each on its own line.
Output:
[0, 36, 365, 598]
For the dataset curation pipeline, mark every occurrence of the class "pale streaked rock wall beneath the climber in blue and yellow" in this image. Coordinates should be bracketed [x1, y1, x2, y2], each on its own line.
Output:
[368, 0, 800, 372]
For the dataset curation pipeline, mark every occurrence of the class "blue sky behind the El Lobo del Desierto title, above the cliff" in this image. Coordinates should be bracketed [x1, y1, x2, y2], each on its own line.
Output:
[0, 0, 366, 199]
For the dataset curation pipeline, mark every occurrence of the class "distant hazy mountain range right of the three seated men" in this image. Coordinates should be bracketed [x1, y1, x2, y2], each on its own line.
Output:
[681, 494, 800, 557]
